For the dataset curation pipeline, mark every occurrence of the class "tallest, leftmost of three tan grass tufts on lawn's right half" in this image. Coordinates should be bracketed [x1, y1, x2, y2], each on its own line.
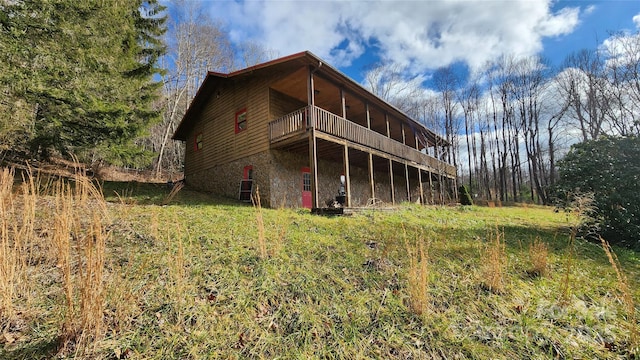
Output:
[404, 231, 431, 316]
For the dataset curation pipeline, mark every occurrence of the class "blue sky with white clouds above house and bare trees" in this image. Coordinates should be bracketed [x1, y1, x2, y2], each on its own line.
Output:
[199, 0, 640, 82]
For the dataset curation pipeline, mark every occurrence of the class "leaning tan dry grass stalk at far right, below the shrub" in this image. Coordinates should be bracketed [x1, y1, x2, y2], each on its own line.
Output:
[599, 236, 640, 355]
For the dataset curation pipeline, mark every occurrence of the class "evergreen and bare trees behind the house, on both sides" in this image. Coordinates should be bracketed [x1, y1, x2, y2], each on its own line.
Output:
[0, 0, 640, 210]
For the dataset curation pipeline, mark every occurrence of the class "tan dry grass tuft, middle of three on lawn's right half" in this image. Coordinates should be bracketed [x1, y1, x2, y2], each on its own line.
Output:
[480, 227, 507, 294]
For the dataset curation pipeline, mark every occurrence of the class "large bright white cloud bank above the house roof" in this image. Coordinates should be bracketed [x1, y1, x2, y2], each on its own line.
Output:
[205, 0, 579, 68]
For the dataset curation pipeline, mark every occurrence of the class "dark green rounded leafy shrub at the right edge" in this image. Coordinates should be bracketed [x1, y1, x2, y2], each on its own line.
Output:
[556, 137, 640, 249]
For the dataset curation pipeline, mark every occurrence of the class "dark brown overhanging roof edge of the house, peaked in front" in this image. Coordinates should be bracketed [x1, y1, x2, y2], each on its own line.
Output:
[173, 51, 447, 144]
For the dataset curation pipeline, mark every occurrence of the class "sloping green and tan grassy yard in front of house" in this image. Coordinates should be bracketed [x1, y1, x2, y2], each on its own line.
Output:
[0, 171, 640, 359]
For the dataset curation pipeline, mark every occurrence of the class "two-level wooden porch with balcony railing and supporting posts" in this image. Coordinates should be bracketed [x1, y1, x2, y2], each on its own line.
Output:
[269, 105, 456, 209]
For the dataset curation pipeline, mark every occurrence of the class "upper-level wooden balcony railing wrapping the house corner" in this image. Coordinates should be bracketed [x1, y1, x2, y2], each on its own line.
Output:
[269, 106, 456, 178]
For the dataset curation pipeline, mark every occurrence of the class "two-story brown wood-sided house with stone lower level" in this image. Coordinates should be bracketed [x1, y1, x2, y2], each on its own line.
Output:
[173, 52, 456, 208]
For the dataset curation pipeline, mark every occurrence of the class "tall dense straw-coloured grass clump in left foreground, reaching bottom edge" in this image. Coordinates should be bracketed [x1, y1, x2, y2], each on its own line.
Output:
[53, 173, 108, 353]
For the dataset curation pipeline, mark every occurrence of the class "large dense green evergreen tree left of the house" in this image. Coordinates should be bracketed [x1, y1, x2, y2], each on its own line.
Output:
[0, 0, 165, 164]
